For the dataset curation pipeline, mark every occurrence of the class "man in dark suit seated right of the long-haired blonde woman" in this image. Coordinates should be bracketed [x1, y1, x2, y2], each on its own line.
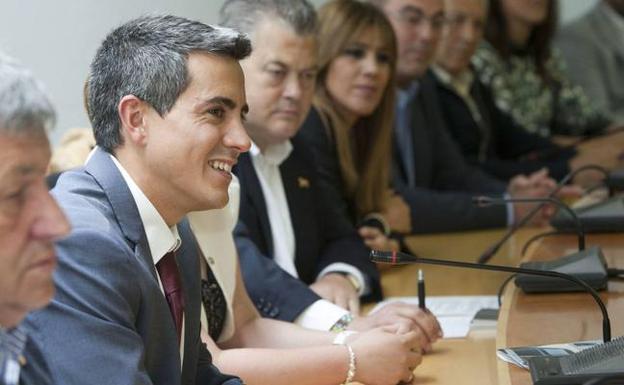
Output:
[371, 0, 554, 232]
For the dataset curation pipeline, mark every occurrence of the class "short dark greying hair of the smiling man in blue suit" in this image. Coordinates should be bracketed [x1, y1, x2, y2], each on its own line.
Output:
[85, 15, 251, 153]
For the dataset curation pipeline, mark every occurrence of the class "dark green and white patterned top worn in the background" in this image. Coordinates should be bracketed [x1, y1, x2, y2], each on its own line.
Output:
[473, 42, 611, 137]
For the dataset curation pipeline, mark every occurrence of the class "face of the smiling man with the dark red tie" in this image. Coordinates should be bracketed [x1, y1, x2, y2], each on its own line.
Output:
[137, 53, 250, 214]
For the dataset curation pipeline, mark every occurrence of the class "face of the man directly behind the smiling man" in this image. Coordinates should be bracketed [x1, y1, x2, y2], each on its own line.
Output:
[241, 20, 317, 149]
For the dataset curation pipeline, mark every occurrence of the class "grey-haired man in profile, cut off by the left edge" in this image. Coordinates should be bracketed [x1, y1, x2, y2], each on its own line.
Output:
[0, 53, 69, 385]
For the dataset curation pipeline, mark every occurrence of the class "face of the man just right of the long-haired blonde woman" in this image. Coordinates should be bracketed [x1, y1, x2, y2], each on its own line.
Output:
[383, 0, 444, 83]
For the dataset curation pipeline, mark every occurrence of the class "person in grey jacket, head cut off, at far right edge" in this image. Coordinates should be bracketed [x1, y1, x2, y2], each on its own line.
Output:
[555, 0, 624, 124]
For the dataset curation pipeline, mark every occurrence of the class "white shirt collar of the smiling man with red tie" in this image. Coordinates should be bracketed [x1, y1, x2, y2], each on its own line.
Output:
[111, 155, 182, 265]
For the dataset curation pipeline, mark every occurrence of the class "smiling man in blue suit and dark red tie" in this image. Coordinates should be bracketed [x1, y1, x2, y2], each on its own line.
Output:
[22, 16, 250, 385]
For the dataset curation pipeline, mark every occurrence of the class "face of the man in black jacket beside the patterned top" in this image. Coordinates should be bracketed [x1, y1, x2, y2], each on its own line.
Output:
[437, 0, 486, 75]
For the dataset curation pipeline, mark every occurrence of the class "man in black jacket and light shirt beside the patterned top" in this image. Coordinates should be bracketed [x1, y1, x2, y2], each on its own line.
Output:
[428, 0, 576, 181]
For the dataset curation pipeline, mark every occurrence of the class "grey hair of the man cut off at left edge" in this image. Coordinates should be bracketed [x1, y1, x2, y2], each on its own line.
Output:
[0, 52, 56, 135]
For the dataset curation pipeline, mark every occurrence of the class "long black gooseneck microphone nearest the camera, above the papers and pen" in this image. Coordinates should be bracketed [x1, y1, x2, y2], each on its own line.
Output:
[370, 250, 611, 342]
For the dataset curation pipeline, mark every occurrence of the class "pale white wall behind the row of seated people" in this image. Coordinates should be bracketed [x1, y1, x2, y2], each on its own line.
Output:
[0, 0, 597, 141]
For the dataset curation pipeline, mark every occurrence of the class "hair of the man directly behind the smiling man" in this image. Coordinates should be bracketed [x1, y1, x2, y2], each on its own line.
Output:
[219, 0, 316, 36]
